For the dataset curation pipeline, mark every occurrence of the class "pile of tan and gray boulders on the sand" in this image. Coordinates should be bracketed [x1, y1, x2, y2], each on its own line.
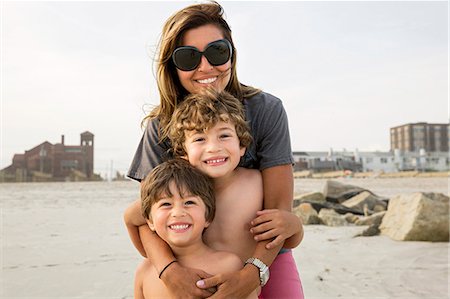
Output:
[293, 180, 449, 242]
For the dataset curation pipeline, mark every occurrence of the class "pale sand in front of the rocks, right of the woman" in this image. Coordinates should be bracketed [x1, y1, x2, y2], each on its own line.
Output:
[294, 225, 449, 299]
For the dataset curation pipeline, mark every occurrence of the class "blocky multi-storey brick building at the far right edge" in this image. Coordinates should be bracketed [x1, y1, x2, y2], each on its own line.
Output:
[391, 122, 450, 152]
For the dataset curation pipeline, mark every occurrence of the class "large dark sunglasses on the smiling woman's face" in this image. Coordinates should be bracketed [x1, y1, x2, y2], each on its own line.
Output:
[172, 39, 233, 71]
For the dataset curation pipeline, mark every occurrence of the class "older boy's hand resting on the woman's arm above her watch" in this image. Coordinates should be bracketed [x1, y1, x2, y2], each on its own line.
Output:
[250, 209, 303, 249]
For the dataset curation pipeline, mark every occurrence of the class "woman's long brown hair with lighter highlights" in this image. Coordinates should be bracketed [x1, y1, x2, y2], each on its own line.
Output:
[144, 1, 260, 135]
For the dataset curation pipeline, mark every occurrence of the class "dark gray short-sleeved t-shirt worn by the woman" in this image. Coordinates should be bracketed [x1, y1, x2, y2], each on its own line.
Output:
[127, 92, 294, 181]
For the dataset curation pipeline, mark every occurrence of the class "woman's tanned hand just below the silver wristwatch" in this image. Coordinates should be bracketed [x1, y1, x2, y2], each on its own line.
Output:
[197, 265, 259, 299]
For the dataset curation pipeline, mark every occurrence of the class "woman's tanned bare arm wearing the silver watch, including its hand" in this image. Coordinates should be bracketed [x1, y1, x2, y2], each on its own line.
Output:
[197, 165, 294, 298]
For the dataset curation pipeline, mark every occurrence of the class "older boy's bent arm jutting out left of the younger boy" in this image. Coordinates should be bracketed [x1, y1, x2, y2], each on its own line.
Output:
[123, 199, 147, 257]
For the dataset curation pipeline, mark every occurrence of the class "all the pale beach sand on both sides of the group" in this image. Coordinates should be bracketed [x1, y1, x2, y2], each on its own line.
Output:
[0, 178, 449, 299]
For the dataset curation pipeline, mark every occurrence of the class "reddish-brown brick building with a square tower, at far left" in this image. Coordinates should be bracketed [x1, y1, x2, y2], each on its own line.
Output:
[0, 131, 97, 182]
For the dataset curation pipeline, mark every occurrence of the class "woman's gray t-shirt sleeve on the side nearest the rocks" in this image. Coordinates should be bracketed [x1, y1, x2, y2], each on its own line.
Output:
[255, 95, 294, 170]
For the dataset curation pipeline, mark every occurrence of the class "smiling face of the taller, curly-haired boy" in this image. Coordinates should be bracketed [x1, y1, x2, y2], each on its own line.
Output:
[184, 121, 245, 179]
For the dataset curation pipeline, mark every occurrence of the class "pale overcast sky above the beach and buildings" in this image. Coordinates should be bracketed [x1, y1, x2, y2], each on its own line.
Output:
[0, 1, 448, 175]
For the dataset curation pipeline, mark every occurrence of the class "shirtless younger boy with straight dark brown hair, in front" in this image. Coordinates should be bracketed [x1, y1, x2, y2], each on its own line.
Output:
[134, 159, 256, 299]
